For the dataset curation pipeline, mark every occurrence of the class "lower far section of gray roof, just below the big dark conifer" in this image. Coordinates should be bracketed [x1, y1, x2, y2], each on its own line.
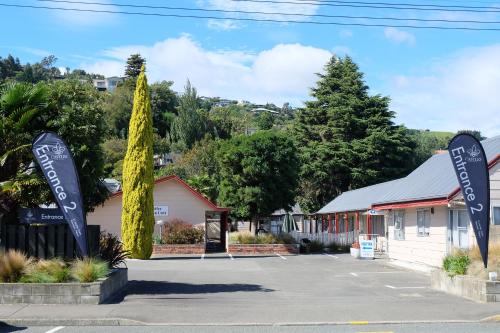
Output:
[318, 178, 404, 214]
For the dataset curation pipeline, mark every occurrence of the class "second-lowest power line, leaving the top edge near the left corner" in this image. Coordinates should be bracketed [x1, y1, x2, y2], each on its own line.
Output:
[32, 0, 500, 24]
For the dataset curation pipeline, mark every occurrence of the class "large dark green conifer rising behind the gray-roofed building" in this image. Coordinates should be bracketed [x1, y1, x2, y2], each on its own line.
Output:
[294, 56, 413, 212]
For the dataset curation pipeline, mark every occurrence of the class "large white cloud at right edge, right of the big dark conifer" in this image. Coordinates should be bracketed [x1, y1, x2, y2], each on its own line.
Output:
[386, 44, 500, 136]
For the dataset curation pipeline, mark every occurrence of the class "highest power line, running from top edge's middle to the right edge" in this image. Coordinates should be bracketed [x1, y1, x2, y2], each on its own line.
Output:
[231, 0, 500, 13]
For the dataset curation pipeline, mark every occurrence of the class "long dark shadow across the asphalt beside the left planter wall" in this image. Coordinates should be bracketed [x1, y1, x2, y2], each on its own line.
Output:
[108, 280, 274, 304]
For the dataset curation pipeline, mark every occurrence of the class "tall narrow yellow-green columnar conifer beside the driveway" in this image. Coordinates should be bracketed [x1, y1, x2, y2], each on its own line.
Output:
[122, 66, 154, 259]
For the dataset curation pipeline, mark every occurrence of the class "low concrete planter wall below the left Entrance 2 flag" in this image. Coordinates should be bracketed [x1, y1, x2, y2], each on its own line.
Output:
[0, 268, 128, 304]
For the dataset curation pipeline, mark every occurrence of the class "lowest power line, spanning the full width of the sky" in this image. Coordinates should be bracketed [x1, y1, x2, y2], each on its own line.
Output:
[0, 3, 500, 31]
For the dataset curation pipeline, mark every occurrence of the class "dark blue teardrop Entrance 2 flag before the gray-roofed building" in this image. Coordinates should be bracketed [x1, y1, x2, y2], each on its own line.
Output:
[448, 133, 490, 268]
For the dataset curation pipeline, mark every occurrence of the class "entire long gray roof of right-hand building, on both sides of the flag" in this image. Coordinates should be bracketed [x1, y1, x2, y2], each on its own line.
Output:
[318, 136, 500, 214]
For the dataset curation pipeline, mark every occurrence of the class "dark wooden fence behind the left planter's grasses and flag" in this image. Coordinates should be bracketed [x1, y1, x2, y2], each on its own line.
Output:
[0, 222, 100, 259]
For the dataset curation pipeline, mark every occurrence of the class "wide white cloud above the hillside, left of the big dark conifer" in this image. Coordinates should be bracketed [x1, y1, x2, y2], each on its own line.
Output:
[80, 35, 332, 105]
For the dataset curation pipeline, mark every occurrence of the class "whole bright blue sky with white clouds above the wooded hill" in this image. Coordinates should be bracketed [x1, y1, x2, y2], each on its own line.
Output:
[0, 0, 500, 136]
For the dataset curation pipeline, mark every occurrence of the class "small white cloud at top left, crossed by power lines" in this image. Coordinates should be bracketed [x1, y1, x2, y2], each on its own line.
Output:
[44, 0, 118, 27]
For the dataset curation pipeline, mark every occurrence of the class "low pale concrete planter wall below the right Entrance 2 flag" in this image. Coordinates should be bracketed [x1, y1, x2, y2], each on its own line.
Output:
[431, 269, 500, 302]
